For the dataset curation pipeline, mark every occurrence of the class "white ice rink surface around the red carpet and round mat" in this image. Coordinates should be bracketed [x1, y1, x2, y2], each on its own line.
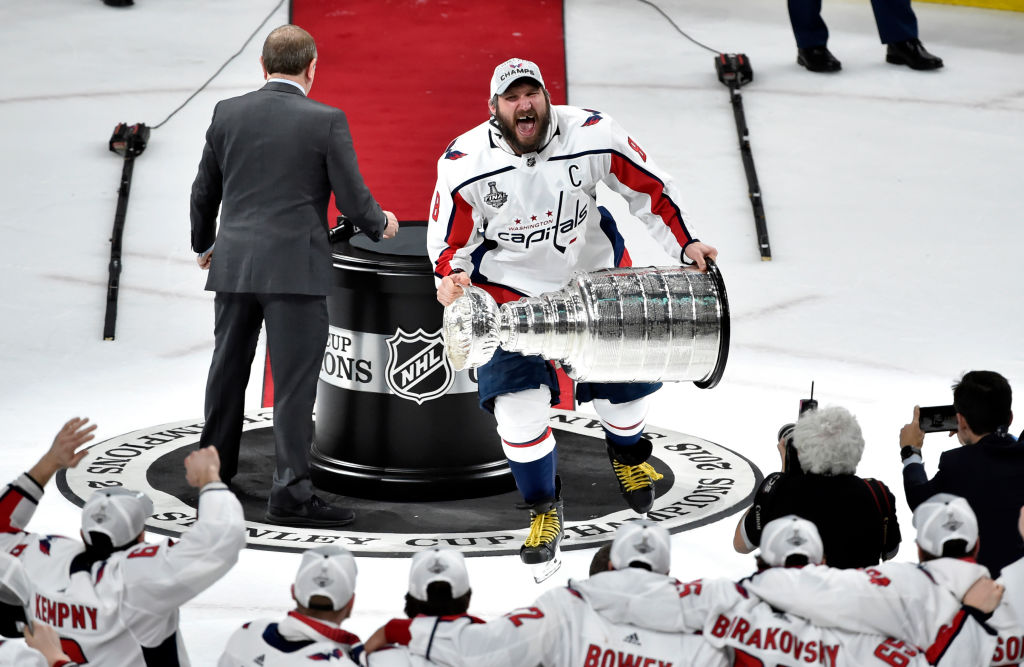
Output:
[0, 0, 1024, 666]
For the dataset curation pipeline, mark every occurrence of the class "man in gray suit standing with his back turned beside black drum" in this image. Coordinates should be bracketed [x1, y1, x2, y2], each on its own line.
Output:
[191, 26, 398, 527]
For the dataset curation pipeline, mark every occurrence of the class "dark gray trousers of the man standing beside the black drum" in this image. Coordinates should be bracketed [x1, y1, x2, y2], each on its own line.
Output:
[200, 292, 328, 507]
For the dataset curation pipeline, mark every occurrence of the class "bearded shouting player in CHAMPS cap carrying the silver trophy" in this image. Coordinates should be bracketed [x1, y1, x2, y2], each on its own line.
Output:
[427, 58, 718, 578]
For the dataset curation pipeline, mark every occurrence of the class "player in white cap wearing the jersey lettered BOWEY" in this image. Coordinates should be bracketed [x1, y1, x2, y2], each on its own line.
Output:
[371, 520, 729, 667]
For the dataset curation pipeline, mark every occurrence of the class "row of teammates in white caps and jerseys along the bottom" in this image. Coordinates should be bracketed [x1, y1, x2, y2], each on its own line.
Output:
[0, 399, 1024, 667]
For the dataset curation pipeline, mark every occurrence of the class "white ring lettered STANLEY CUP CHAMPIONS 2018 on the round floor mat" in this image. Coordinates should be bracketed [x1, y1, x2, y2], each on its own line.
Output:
[57, 409, 762, 556]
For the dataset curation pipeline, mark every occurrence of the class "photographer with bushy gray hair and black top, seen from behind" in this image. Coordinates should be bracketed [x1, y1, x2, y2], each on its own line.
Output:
[733, 400, 900, 568]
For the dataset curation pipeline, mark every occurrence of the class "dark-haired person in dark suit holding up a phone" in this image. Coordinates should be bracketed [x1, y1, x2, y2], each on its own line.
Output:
[899, 371, 1024, 577]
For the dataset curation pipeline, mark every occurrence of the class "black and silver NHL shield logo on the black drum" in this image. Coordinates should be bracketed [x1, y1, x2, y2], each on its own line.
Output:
[384, 327, 455, 405]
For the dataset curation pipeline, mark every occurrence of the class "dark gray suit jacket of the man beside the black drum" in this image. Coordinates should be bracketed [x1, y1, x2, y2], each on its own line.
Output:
[191, 82, 385, 295]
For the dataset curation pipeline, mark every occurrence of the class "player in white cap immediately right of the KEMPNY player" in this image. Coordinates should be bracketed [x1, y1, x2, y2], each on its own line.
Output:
[217, 544, 362, 667]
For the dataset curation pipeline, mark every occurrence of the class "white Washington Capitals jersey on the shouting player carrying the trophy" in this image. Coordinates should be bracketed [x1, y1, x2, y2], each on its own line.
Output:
[427, 106, 695, 303]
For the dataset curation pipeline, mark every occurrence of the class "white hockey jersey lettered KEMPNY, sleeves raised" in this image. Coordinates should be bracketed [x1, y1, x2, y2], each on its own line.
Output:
[0, 474, 245, 667]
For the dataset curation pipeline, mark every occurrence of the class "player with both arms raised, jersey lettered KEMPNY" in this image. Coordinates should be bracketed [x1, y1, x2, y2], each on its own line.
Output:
[0, 418, 245, 667]
